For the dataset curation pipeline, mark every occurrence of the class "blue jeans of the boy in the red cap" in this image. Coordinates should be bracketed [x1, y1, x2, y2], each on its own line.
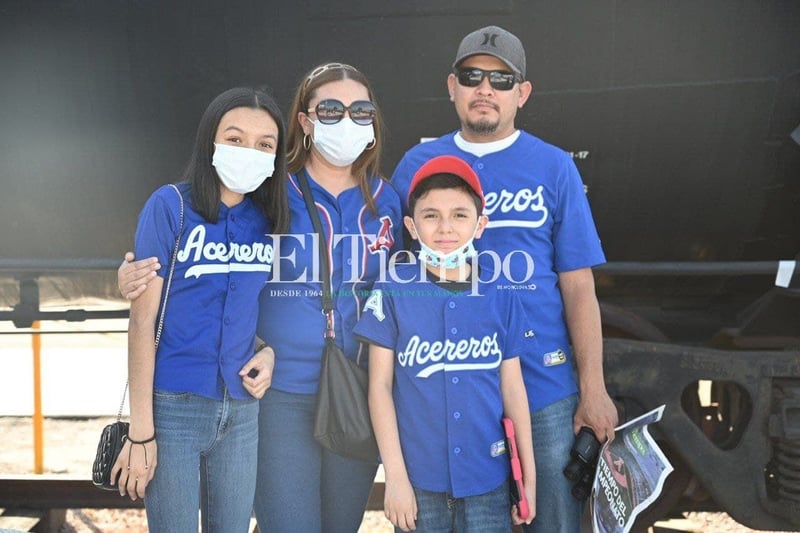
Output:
[410, 481, 511, 533]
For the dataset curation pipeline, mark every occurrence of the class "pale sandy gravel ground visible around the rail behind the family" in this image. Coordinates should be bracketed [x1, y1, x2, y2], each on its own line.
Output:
[0, 417, 796, 533]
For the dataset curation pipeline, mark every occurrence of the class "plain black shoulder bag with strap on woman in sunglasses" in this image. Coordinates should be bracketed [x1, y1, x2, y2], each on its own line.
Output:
[297, 169, 378, 463]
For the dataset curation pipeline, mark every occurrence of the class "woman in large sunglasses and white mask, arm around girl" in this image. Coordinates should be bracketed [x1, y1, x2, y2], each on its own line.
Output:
[119, 63, 402, 533]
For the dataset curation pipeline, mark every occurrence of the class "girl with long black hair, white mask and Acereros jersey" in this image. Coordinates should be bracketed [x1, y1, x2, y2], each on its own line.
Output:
[112, 88, 288, 532]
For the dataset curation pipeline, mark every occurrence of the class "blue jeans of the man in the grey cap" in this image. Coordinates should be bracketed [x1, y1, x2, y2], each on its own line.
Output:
[523, 394, 583, 533]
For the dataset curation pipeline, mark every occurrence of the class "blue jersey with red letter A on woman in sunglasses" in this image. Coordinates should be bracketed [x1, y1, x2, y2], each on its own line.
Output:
[258, 175, 402, 394]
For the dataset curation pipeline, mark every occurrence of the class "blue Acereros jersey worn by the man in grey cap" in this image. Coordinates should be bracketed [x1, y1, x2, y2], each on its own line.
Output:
[392, 131, 605, 411]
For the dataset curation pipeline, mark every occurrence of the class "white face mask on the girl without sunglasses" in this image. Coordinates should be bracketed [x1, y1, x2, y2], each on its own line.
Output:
[211, 143, 275, 194]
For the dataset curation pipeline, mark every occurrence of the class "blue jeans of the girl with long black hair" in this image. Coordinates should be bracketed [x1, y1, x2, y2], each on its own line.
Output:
[145, 391, 258, 533]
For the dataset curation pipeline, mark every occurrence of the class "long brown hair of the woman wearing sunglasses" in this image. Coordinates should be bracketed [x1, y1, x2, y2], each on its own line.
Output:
[287, 63, 383, 213]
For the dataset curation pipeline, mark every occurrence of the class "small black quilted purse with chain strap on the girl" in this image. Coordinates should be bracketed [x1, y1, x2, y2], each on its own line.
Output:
[92, 184, 183, 490]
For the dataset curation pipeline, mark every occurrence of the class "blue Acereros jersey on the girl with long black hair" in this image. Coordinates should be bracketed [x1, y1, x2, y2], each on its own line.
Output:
[134, 183, 273, 399]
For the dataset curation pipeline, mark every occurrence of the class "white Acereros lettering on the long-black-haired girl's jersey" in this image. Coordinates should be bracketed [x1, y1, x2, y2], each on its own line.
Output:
[178, 225, 273, 278]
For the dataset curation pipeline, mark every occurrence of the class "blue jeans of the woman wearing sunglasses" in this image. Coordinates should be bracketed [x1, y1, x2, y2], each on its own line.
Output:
[255, 389, 378, 533]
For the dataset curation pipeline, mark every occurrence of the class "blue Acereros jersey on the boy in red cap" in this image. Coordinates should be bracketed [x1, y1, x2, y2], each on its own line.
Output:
[355, 264, 537, 498]
